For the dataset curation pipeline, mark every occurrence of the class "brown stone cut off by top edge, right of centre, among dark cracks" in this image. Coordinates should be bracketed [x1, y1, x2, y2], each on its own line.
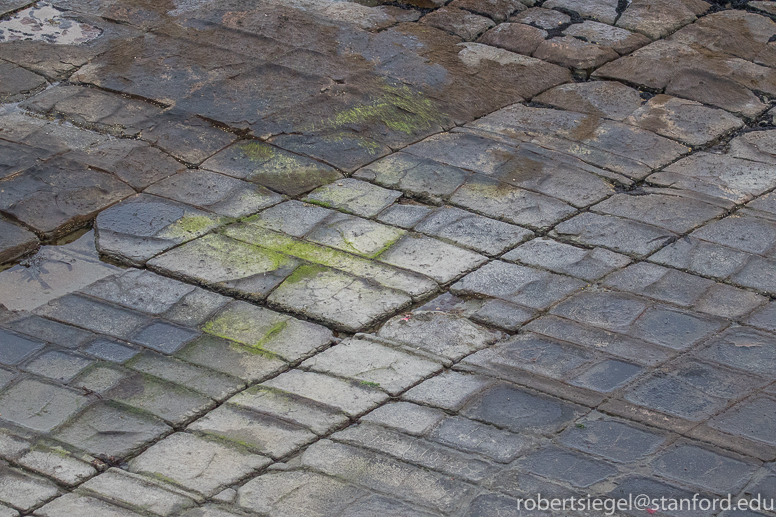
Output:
[617, 0, 709, 39]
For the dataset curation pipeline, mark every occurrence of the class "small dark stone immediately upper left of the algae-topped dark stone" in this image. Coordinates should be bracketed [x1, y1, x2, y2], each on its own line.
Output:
[140, 111, 237, 164]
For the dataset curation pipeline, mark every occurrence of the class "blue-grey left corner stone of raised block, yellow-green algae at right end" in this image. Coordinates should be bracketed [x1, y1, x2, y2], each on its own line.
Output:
[95, 194, 226, 265]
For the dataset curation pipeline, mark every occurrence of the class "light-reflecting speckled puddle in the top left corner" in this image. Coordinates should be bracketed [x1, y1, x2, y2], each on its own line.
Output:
[0, 2, 102, 45]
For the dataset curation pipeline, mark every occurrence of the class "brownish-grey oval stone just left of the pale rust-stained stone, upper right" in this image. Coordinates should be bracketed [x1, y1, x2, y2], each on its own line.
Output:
[536, 81, 644, 121]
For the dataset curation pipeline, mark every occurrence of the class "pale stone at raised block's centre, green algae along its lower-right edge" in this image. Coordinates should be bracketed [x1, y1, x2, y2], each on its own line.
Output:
[306, 214, 406, 258]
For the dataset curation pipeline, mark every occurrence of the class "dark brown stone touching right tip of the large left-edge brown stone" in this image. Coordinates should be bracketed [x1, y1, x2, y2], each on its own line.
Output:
[65, 140, 185, 190]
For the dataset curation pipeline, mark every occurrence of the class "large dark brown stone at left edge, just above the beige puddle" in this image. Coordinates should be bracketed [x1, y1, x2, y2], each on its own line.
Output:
[0, 158, 134, 237]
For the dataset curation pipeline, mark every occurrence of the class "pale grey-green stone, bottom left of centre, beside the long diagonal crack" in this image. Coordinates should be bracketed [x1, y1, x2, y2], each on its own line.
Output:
[188, 405, 317, 458]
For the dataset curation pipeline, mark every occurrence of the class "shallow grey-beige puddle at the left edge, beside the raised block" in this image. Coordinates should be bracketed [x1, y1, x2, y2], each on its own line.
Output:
[0, 230, 121, 311]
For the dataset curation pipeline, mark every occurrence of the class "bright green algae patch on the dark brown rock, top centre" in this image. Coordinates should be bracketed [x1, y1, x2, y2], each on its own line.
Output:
[310, 84, 447, 135]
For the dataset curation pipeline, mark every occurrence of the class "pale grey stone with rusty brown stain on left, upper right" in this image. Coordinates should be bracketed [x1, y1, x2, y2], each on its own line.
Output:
[625, 95, 744, 146]
